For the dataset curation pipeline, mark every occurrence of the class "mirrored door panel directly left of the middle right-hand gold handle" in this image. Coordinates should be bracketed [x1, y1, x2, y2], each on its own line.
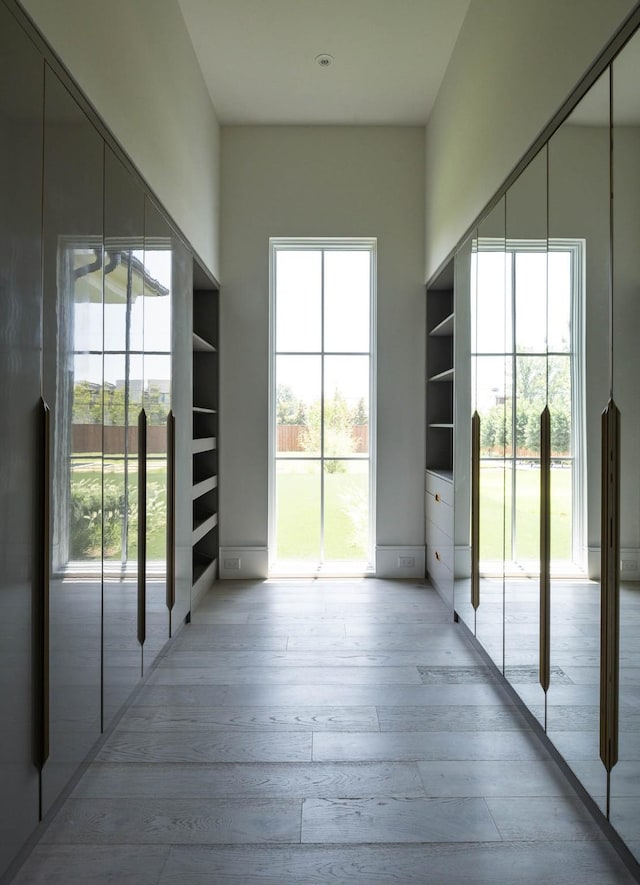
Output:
[505, 148, 547, 724]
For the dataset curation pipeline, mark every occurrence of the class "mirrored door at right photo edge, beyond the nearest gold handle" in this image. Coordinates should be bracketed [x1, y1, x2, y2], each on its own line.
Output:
[610, 34, 640, 855]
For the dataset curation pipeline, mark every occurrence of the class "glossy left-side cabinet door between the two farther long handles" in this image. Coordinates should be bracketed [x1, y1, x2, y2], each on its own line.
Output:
[141, 199, 174, 670]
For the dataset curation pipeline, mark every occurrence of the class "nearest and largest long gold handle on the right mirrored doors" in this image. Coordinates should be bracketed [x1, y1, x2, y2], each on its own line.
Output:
[600, 399, 620, 788]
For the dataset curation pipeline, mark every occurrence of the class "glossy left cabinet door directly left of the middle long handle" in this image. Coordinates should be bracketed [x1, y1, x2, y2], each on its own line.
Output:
[102, 148, 144, 728]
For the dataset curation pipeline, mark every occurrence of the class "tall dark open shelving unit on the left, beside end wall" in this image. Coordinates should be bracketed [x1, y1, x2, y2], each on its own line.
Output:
[191, 266, 219, 605]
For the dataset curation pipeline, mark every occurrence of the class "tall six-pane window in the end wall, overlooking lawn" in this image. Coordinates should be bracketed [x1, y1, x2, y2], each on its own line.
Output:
[269, 239, 375, 574]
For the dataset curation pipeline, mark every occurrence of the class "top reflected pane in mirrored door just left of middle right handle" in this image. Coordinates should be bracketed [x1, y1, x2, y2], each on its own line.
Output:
[515, 251, 547, 353]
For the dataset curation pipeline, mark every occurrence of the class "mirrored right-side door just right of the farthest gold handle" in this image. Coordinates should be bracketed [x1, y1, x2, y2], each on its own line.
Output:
[471, 197, 513, 670]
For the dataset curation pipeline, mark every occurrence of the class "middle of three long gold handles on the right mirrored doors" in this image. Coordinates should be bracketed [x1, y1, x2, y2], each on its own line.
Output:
[540, 406, 551, 692]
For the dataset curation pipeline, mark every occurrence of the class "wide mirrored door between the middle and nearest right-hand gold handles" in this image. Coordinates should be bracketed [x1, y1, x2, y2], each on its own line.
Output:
[547, 67, 609, 807]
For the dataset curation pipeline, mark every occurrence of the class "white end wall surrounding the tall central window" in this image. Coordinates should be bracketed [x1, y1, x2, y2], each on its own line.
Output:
[220, 127, 424, 576]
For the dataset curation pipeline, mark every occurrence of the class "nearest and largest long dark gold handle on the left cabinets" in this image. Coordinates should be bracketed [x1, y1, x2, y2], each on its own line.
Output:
[35, 398, 51, 771]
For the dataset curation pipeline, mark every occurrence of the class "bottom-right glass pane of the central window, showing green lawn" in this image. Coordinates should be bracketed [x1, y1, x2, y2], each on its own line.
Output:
[324, 459, 369, 560]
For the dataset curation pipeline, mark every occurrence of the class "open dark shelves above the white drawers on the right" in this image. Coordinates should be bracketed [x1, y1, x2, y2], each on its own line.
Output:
[426, 262, 455, 479]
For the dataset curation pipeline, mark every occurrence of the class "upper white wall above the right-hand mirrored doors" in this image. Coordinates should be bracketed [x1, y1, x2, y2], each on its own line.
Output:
[425, 0, 636, 279]
